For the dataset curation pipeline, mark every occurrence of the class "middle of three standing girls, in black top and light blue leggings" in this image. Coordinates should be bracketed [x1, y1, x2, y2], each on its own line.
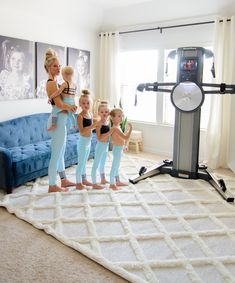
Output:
[91, 102, 113, 189]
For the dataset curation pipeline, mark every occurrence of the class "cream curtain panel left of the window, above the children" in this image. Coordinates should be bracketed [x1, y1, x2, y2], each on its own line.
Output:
[99, 31, 120, 107]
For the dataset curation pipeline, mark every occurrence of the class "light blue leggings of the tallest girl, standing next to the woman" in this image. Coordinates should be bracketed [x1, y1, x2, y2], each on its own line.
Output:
[76, 135, 91, 184]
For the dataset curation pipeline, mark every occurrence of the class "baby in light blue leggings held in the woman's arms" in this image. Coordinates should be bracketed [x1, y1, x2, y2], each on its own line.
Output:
[48, 66, 77, 131]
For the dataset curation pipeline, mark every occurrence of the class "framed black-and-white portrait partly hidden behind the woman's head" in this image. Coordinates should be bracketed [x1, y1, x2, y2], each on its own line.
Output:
[35, 42, 66, 98]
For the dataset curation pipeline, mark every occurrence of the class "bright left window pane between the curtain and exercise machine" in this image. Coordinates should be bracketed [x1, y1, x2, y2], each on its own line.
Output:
[120, 50, 158, 123]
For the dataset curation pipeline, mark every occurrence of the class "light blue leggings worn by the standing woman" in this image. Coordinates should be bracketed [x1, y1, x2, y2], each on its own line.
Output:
[48, 112, 68, 186]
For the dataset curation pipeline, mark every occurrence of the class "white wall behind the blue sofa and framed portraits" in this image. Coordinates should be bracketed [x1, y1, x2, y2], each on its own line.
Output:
[0, 0, 103, 121]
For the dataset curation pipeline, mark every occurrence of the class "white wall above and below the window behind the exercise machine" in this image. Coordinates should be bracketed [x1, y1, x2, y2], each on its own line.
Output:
[120, 19, 214, 161]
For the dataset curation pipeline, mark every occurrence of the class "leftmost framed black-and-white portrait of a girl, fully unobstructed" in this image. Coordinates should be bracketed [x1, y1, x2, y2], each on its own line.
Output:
[0, 36, 35, 100]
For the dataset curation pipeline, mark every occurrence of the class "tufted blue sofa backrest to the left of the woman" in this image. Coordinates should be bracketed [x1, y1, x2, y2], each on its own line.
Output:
[0, 113, 50, 148]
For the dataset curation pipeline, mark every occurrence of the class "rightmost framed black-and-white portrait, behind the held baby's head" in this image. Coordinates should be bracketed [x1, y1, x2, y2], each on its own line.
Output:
[67, 47, 90, 93]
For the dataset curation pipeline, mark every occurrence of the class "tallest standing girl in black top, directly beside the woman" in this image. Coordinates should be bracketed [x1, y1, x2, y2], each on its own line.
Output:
[76, 90, 98, 190]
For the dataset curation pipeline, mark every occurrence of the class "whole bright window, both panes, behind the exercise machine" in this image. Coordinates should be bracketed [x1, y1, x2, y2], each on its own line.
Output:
[120, 47, 213, 129]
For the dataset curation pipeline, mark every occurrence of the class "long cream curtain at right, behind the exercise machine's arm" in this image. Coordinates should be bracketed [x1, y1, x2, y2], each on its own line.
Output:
[207, 16, 235, 169]
